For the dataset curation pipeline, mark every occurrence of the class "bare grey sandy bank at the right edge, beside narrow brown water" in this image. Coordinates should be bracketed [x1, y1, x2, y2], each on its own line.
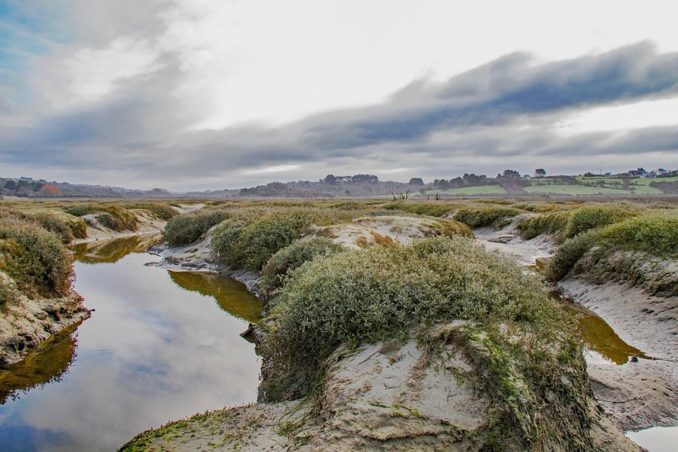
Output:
[559, 278, 678, 430]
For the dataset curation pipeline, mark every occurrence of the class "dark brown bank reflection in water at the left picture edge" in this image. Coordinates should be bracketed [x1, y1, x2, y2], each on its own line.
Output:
[0, 325, 77, 405]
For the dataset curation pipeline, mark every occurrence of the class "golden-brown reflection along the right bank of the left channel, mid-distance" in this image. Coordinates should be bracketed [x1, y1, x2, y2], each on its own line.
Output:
[170, 272, 264, 323]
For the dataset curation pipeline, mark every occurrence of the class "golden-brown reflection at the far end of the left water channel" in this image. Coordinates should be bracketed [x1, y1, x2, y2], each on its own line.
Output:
[72, 234, 162, 264]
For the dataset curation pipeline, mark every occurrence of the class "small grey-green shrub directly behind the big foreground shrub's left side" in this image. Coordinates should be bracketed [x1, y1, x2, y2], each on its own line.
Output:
[259, 237, 343, 297]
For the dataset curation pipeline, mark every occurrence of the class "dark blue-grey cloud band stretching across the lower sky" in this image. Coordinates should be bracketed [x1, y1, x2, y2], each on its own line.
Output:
[0, 43, 678, 185]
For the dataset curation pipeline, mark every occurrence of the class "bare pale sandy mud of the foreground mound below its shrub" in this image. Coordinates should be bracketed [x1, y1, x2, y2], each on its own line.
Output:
[122, 322, 638, 451]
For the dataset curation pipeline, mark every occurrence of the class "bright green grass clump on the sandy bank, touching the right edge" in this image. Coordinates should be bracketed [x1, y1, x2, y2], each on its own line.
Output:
[547, 215, 678, 281]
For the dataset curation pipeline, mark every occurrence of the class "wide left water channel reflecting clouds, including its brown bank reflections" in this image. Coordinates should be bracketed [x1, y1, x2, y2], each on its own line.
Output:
[0, 237, 262, 451]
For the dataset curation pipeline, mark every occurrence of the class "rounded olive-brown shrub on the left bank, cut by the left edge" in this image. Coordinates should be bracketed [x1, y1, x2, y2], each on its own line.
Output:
[0, 219, 72, 297]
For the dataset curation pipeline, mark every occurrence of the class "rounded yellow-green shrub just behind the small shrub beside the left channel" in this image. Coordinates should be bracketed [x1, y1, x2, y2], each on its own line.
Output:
[238, 210, 314, 270]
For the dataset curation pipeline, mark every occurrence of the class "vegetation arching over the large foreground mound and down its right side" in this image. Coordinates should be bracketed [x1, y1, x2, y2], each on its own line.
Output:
[260, 238, 590, 449]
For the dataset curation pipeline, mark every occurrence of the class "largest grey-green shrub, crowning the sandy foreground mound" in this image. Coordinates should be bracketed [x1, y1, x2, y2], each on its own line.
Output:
[261, 238, 563, 399]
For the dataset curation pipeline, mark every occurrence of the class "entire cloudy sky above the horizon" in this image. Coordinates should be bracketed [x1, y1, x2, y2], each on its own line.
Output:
[0, 0, 678, 191]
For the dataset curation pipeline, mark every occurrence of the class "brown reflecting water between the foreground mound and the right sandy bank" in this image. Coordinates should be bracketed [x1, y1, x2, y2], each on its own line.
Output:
[561, 301, 651, 364]
